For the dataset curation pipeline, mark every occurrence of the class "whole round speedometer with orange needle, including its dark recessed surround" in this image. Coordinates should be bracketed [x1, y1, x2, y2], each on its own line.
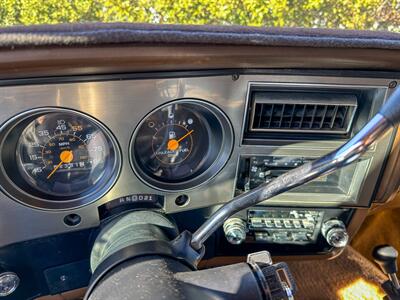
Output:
[2, 109, 119, 208]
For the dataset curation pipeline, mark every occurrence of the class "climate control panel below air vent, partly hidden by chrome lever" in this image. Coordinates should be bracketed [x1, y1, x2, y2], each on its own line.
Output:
[235, 155, 370, 206]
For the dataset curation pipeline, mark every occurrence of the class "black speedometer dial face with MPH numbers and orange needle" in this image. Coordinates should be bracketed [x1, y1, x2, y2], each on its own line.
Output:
[16, 112, 115, 198]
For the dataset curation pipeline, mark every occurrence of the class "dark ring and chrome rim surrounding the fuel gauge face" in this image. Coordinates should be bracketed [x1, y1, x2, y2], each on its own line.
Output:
[129, 98, 234, 193]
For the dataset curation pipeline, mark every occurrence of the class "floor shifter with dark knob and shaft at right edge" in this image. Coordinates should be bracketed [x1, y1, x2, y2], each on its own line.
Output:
[372, 245, 400, 300]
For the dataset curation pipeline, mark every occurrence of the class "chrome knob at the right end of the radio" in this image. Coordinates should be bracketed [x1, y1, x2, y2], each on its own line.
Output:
[321, 219, 349, 248]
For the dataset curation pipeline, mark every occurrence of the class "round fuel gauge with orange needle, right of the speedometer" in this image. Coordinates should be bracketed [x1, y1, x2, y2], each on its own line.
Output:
[131, 99, 233, 190]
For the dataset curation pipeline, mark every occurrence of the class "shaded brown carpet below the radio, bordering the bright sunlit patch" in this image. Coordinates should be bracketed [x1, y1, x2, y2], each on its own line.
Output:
[288, 247, 387, 300]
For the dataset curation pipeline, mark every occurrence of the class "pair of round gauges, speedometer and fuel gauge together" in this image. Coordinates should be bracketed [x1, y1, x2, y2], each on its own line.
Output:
[0, 99, 233, 209]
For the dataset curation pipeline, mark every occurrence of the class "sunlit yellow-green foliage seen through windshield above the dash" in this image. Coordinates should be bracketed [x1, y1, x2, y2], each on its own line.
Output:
[0, 0, 400, 32]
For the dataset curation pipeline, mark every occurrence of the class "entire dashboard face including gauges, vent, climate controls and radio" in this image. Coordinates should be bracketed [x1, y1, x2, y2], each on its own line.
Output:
[0, 71, 397, 298]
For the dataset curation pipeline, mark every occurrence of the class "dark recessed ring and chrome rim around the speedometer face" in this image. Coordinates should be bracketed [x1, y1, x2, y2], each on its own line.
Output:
[0, 107, 122, 210]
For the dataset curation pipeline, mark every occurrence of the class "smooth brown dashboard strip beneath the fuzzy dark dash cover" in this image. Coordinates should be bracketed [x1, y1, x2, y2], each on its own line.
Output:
[0, 44, 400, 79]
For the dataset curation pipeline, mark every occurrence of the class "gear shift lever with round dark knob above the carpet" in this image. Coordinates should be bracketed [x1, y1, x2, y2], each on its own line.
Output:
[372, 245, 400, 290]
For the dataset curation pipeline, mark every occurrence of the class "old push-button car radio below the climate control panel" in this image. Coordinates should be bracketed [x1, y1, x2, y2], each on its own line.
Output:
[221, 206, 355, 255]
